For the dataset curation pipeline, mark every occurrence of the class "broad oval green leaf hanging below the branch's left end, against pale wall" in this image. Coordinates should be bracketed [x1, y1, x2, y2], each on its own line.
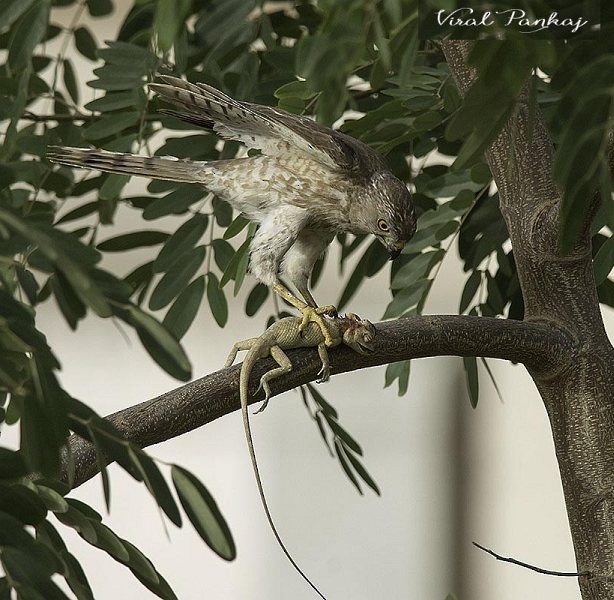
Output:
[171, 465, 237, 560]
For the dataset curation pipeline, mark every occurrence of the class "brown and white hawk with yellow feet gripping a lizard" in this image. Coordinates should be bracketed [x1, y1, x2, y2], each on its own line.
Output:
[48, 76, 416, 344]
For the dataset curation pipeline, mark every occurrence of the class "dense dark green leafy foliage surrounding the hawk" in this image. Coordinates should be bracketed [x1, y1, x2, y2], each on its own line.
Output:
[0, 0, 614, 598]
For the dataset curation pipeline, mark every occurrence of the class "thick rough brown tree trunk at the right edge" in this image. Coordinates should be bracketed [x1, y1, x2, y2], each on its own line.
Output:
[444, 41, 614, 600]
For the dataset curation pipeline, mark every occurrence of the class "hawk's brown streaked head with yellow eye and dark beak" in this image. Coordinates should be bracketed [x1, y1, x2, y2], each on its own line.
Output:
[351, 171, 416, 260]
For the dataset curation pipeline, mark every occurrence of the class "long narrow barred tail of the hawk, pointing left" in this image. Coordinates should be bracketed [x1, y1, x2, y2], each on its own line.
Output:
[47, 146, 208, 183]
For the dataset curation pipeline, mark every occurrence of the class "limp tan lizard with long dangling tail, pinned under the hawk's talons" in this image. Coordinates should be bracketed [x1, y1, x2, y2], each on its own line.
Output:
[224, 313, 375, 600]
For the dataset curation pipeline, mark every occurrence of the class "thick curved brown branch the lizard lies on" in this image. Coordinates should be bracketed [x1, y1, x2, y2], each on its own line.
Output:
[68, 315, 572, 487]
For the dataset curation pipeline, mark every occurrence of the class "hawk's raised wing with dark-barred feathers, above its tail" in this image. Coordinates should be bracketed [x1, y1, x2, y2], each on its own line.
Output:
[149, 76, 375, 171]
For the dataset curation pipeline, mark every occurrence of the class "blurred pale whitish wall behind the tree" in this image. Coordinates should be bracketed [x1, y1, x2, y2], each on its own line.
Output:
[6, 2, 614, 600]
